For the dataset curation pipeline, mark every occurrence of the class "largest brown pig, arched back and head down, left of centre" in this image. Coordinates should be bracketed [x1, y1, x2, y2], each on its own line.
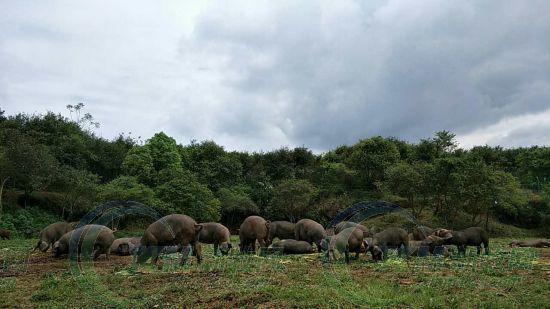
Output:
[137, 214, 202, 265]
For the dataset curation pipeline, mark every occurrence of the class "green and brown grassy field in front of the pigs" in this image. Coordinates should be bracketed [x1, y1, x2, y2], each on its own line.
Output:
[0, 239, 550, 308]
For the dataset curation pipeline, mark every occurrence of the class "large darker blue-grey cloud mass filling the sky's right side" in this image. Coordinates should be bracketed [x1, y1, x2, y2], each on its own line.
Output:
[177, 1, 550, 149]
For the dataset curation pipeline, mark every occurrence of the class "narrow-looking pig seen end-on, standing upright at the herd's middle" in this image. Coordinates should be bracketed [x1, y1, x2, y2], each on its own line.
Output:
[239, 216, 270, 253]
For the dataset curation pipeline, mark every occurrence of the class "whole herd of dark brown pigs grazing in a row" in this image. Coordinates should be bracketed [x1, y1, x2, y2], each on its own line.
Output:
[23, 214, 520, 264]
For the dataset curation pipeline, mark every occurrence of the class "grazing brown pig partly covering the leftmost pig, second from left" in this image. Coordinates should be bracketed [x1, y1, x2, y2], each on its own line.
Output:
[52, 224, 115, 260]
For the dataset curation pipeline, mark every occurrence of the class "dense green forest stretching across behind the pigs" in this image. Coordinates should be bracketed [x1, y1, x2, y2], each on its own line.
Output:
[0, 104, 550, 235]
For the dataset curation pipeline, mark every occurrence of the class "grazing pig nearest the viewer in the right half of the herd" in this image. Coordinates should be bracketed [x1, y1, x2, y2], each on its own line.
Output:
[321, 227, 363, 263]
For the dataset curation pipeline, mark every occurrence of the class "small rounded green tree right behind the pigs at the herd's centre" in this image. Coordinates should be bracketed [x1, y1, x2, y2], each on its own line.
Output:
[268, 179, 318, 222]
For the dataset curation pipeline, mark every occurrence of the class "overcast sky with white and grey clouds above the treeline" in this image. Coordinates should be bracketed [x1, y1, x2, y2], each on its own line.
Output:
[0, 0, 550, 152]
